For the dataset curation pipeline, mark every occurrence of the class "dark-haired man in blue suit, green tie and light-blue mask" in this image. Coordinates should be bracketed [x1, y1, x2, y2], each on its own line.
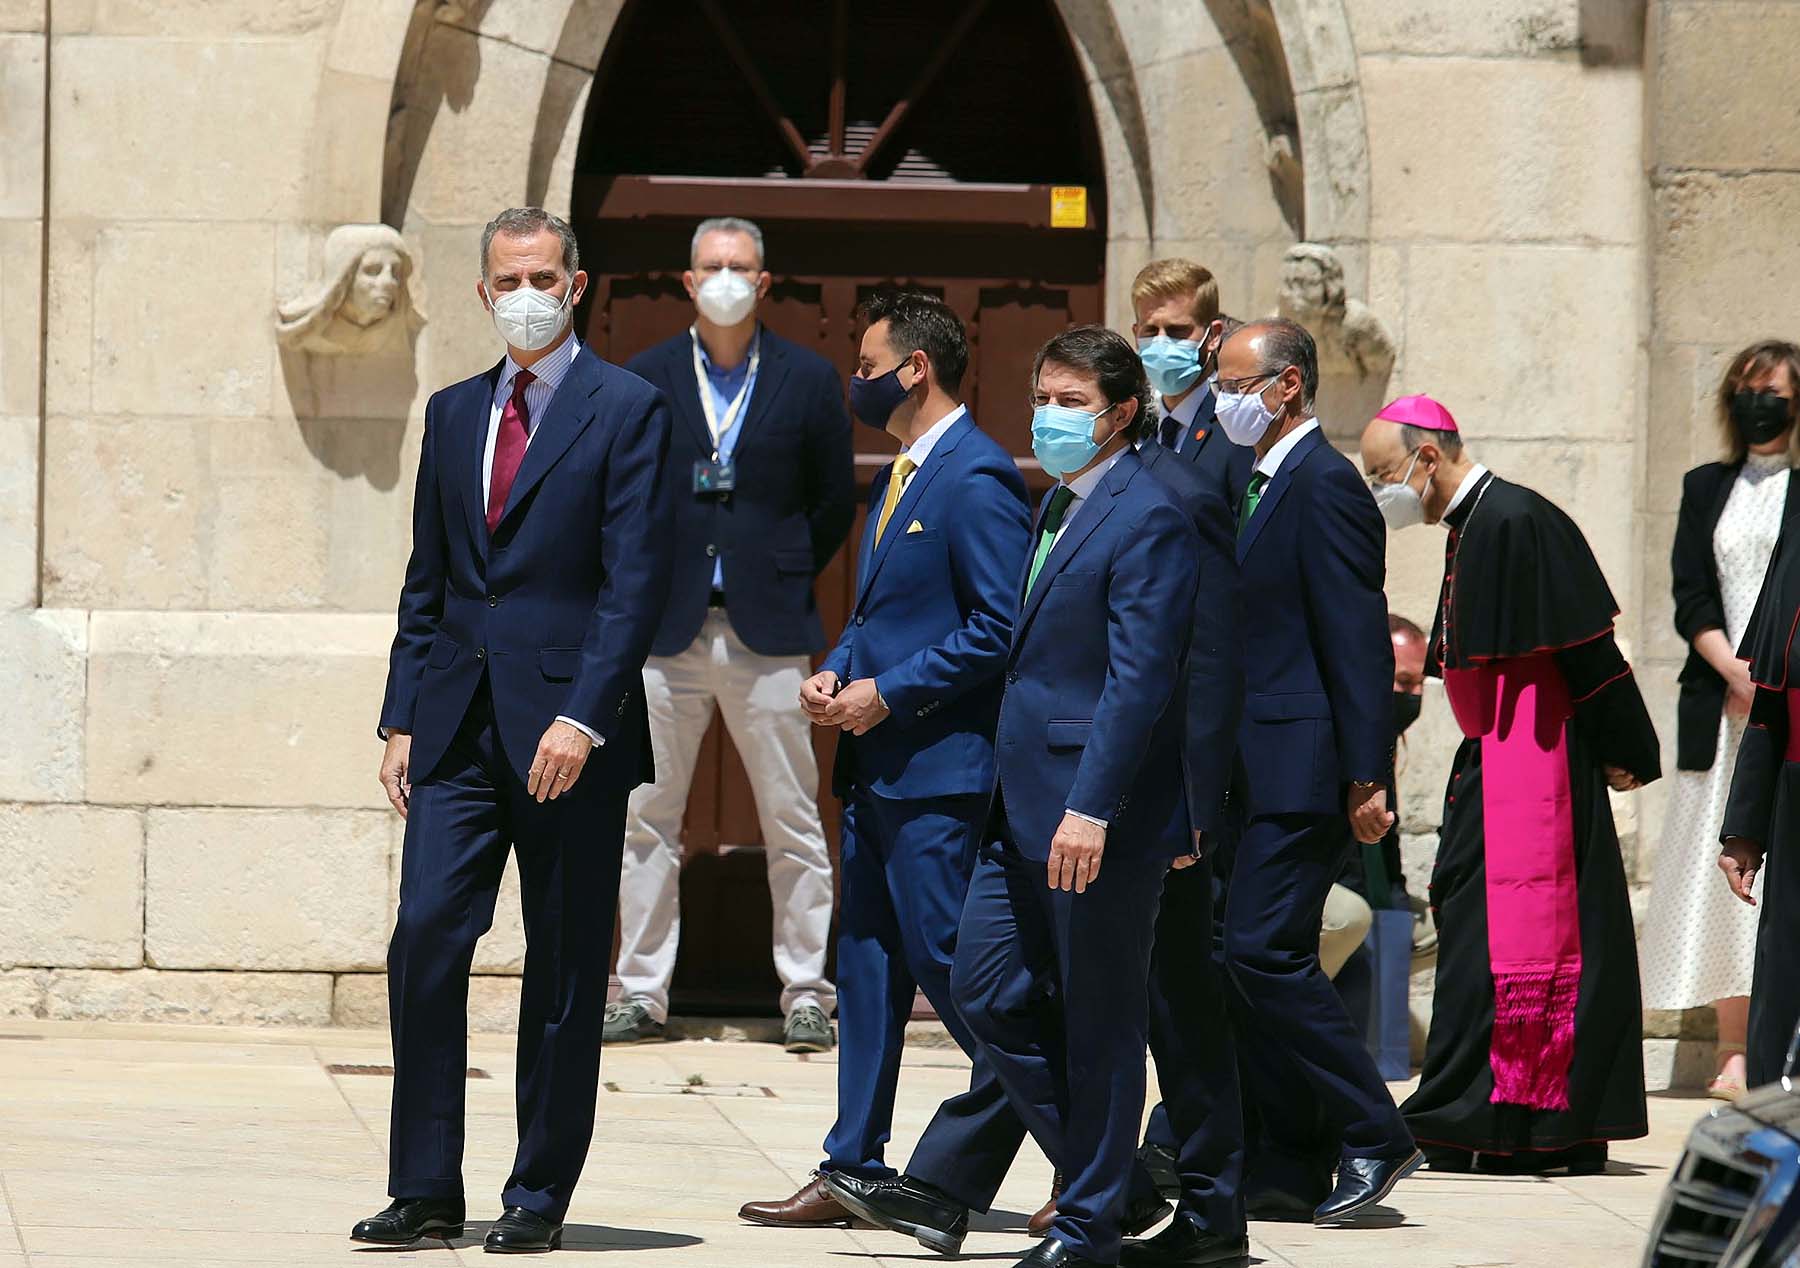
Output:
[833, 326, 1199, 1268]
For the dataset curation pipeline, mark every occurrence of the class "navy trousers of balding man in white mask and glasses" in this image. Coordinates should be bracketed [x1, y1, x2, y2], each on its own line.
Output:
[1224, 814, 1413, 1200]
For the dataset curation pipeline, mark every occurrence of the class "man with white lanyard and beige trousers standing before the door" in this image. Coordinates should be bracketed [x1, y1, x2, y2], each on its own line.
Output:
[605, 216, 855, 1052]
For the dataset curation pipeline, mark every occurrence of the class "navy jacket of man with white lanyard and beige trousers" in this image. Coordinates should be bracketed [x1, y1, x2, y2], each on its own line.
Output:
[625, 326, 857, 656]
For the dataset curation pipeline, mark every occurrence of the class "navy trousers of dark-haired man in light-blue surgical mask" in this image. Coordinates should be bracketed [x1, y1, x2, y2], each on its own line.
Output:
[950, 834, 1168, 1263]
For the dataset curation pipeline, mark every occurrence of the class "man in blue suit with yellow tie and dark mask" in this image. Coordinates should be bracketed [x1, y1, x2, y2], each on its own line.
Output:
[740, 292, 1031, 1227]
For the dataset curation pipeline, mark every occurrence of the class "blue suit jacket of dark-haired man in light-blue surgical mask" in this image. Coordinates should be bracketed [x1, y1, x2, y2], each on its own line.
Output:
[995, 450, 1201, 860]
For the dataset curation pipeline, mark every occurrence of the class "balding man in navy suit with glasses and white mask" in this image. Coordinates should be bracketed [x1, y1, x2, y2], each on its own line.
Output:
[1219, 321, 1422, 1223]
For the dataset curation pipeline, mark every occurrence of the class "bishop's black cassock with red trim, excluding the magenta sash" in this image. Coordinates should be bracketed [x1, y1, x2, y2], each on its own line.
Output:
[1400, 476, 1661, 1155]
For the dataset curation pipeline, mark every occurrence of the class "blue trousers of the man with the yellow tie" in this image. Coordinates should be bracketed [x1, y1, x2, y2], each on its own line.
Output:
[821, 791, 1024, 1210]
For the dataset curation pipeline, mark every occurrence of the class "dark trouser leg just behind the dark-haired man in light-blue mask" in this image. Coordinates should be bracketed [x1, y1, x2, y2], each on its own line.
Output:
[1144, 857, 1244, 1237]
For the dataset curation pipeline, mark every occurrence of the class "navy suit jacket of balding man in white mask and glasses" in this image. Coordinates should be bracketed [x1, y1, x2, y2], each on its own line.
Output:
[1237, 430, 1393, 814]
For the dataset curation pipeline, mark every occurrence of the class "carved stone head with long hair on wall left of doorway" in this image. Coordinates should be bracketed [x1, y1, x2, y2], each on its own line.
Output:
[275, 225, 425, 357]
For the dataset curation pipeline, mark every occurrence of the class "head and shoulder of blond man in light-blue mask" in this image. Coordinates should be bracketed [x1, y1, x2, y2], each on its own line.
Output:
[1130, 256, 1253, 506]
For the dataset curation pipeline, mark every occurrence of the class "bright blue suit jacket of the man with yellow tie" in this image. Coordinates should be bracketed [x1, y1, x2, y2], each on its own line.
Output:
[824, 414, 1031, 798]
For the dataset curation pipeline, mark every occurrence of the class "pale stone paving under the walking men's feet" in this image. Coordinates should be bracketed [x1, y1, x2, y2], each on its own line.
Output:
[0, 1021, 1706, 1268]
